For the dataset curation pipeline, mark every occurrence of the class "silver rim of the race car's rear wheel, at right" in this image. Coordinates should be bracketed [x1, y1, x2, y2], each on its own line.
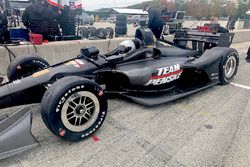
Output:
[224, 56, 237, 78]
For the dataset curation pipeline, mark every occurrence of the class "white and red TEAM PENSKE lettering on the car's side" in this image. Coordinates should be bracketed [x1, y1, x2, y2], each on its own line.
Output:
[145, 64, 183, 86]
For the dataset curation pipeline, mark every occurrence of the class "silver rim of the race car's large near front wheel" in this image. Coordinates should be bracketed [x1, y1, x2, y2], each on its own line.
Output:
[61, 91, 100, 132]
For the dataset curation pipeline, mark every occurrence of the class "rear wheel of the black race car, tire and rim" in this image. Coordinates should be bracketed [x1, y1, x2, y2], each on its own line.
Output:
[219, 49, 239, 85]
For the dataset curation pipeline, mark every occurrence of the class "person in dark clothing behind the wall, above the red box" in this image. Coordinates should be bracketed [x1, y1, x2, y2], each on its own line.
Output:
[22, 0, 59, 40]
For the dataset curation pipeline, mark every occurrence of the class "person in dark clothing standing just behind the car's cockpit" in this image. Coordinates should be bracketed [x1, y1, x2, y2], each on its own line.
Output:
[143, 6, 164, 39]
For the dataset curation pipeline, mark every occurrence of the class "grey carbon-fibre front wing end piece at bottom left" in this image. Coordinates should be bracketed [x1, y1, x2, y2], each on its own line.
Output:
[0, 107, 39, 160]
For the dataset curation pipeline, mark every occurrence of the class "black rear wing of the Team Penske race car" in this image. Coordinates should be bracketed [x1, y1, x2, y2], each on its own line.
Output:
[174, 30, 234, 50]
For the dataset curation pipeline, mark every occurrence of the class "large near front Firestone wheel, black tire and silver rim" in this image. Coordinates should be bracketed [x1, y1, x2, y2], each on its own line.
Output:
[41, 76, 108, 142]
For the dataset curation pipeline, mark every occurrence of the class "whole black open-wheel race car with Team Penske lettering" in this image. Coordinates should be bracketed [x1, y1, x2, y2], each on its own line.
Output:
[0, 29, 239, 157]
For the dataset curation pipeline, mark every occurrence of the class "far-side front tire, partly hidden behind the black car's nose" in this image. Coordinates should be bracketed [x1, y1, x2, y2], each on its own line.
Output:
[7, 55, 50, 81]
